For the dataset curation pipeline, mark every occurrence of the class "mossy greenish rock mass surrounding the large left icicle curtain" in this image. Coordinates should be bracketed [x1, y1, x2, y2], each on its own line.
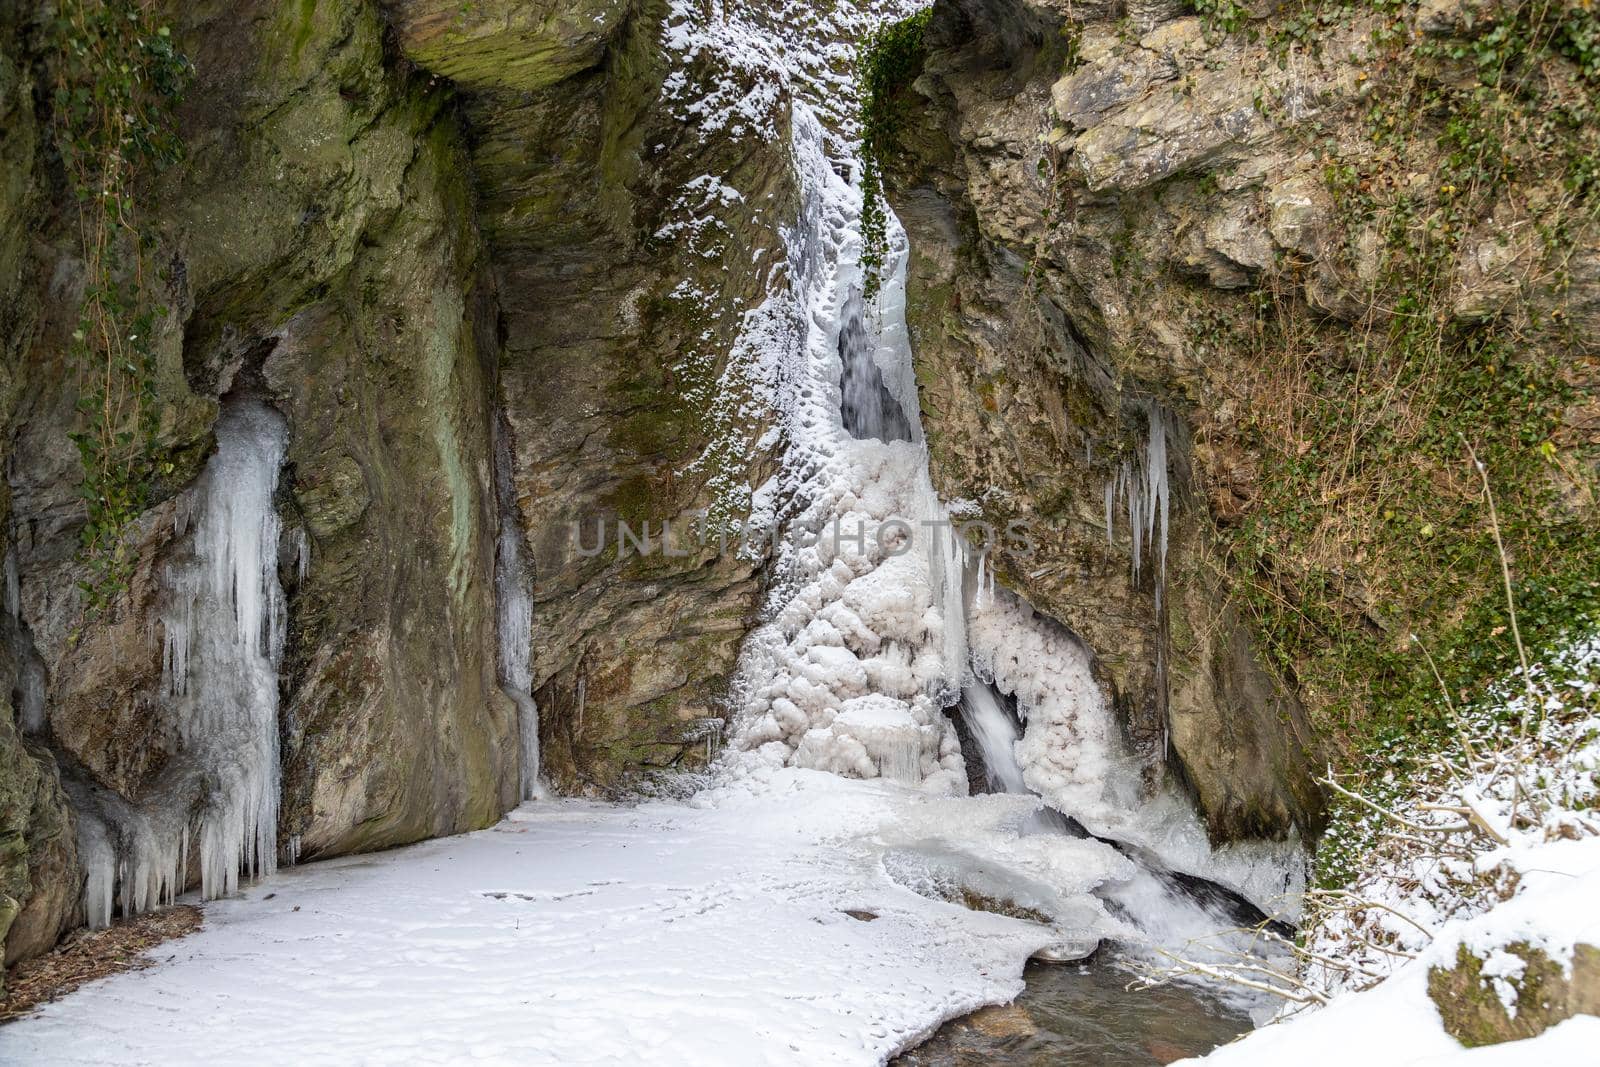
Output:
[10, 5, 517, 934]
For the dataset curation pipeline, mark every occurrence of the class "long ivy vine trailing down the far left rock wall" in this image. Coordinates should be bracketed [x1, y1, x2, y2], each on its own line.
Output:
[48, 0, 192, 613]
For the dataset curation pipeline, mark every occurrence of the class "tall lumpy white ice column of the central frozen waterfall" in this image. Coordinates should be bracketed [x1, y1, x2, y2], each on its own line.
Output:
[736, 102, 965, 792]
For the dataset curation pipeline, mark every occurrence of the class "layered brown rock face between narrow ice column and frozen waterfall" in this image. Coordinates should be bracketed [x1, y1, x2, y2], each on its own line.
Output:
[390, 0, 794, 789]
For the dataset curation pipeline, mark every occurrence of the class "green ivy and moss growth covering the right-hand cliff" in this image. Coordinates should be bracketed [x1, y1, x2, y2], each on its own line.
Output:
[1164, 0, 1600, 885]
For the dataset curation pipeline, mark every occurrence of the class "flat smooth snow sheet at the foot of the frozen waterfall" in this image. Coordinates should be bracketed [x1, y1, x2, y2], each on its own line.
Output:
[0, 769, 1152, 1064]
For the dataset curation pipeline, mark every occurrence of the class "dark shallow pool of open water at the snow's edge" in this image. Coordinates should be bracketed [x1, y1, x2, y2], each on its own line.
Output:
[891, 961, 1250, 1067]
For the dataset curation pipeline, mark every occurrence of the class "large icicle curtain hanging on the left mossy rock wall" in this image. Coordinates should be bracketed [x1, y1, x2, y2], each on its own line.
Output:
[78, 397, 288, 926]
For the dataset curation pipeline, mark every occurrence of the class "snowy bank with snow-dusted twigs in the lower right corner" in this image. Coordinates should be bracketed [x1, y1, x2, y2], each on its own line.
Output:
[1177, 637, 1600, 1067]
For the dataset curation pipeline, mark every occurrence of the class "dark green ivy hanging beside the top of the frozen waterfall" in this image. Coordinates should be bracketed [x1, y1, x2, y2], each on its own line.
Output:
[859, 8, 933, 299]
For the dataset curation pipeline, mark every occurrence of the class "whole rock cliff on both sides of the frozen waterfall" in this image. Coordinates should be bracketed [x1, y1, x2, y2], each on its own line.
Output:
[0, 0, 1568, 979]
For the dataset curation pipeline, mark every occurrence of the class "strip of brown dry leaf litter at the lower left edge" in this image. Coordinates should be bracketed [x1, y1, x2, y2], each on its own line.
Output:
[0, 904, 202, 1022]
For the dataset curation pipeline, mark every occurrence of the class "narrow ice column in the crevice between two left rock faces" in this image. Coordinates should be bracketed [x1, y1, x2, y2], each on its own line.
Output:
[494, 426, 547, 800]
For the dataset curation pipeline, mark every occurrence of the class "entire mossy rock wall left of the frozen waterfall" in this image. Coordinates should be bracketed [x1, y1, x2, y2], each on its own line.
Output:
[0, 0, 792, 958]
